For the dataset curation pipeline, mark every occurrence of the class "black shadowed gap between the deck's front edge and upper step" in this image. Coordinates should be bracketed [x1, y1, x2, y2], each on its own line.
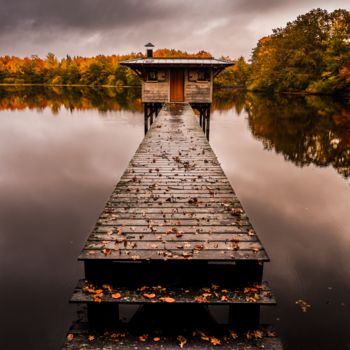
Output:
[84, 260, 263, 288]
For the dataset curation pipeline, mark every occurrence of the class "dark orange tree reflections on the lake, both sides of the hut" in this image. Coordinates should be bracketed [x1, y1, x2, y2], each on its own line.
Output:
[0, 86, 350, 178]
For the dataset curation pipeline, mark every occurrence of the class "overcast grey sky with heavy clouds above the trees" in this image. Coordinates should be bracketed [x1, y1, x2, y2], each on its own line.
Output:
[0, 0, 350, 58]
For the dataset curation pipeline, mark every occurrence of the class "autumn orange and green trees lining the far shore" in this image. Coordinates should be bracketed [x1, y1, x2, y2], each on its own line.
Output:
[0, 9, 350, 99]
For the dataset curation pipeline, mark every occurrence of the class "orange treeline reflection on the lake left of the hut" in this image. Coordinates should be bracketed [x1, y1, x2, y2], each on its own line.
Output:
[0, 86, 142, 113]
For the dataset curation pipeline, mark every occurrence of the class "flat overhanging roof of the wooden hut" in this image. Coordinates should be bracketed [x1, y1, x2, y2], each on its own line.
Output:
[120, 57, 234, 69]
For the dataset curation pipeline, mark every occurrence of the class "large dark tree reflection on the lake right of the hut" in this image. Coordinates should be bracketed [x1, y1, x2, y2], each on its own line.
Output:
[212, 93, 350, 177]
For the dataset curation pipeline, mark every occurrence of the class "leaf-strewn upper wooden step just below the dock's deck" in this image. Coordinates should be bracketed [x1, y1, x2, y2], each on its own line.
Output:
[70, 280, 276, 305]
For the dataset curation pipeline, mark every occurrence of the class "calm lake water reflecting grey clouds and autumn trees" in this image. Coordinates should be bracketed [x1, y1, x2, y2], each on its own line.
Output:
[0, 87, 350, 350]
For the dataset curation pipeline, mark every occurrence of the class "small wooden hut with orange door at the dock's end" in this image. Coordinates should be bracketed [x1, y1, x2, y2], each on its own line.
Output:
[121, 43, 233, 104]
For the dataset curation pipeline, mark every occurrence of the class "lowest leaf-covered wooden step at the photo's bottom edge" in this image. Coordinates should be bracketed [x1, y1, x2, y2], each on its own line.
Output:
[63, 316, 283, 350]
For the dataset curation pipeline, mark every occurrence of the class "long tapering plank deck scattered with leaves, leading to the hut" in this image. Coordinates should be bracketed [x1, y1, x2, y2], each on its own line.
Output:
[79, 104, 269, 262]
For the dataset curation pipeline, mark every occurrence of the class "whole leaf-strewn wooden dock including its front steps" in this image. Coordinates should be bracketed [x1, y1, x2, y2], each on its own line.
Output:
[64, 103, 282, 350]
